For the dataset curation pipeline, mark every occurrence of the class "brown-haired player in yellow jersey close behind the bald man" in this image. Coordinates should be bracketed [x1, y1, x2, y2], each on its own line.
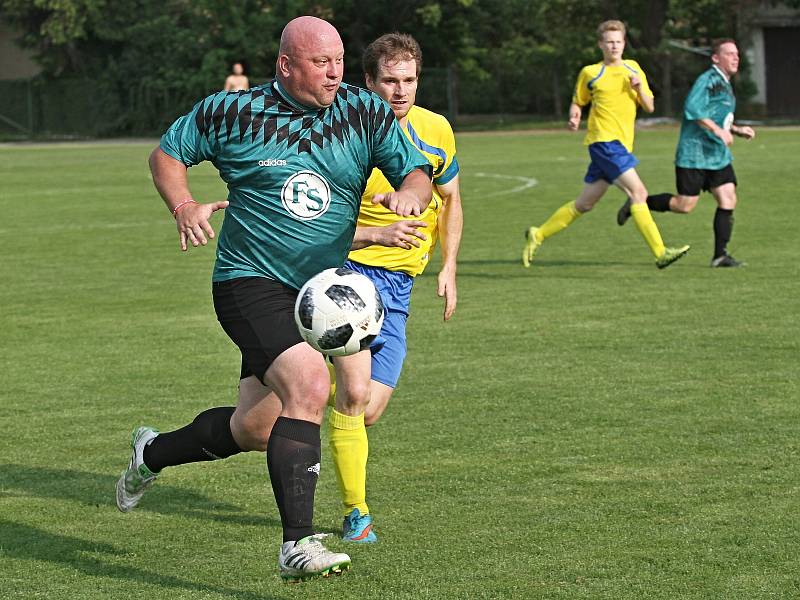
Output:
[329, 33, 463, 542]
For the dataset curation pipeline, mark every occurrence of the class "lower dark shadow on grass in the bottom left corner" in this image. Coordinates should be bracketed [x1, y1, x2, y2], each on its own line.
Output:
[0, 519, 275, 600]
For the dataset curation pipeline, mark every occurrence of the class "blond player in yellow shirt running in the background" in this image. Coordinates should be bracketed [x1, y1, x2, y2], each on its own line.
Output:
[522, 21, 689, 269]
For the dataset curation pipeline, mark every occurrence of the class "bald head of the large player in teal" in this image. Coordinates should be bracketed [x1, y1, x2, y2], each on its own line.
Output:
[275, 17, 344, 108]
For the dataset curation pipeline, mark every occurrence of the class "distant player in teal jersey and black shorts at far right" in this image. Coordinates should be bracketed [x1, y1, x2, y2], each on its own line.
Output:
[617, 39, 756, 267]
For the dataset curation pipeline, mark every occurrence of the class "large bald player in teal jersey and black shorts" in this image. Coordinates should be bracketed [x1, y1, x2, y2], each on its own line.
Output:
[117, 17, 431, 579]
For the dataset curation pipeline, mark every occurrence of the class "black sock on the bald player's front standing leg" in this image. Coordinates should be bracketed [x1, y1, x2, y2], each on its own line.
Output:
[267, 417, 321, 542]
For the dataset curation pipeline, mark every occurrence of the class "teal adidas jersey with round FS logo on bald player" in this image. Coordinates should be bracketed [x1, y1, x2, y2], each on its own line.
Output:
[161, 81, 431, 289]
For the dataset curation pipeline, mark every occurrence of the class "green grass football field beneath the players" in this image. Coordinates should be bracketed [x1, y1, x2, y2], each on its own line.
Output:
[0, 129, 800, 600]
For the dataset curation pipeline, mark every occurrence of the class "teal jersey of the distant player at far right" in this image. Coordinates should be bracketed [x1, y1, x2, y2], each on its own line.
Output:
[675, 67, 736, 171]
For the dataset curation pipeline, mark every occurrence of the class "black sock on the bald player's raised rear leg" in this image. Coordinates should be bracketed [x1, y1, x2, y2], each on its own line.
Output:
[142, 406, 242, 473]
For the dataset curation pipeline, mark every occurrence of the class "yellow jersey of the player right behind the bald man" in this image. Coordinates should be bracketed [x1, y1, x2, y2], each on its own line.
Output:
[348, 106, 458, 277]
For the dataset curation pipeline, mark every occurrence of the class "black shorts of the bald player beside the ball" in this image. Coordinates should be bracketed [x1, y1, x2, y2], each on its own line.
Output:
[212, 277, 303, 382]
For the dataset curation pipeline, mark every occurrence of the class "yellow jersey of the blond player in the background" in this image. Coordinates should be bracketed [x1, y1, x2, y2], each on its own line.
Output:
[572, 60, 653, 152]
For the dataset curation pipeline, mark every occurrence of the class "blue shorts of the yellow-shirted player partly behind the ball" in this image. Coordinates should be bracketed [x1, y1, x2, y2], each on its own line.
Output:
[344, 260, 414, 388]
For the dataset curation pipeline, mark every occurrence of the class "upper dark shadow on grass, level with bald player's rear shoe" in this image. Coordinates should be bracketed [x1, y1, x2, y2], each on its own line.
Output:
[0, 464, 280, 526]
